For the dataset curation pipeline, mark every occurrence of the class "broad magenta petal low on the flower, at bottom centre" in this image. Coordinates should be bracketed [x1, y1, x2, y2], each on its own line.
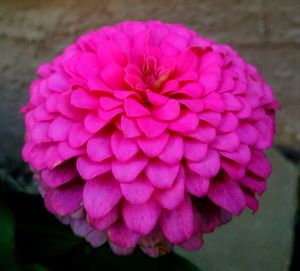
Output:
[122, 198, 161, 235]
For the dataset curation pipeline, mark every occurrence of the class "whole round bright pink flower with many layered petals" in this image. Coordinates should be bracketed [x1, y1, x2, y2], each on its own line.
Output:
[23, 21, 279, 257]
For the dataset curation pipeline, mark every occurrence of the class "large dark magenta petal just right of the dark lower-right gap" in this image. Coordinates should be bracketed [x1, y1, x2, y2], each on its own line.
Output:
[207, 180, 246, 215]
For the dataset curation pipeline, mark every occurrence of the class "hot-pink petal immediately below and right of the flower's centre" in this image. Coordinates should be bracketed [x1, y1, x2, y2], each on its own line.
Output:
[152, 99, 180, 120]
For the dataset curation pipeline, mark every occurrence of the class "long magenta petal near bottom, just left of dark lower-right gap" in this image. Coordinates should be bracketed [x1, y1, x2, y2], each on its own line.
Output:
[160, 196, 194, 244]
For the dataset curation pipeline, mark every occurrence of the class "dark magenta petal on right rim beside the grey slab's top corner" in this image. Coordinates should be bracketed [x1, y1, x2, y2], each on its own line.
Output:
[247, 150, 272, 179]
